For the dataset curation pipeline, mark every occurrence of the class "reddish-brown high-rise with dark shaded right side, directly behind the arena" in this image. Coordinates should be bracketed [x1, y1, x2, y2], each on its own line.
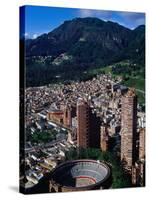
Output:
[77, 99, 100, 148]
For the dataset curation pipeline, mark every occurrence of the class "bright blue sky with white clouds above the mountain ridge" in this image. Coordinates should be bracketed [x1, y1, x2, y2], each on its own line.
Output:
[24, 6, 145, 39]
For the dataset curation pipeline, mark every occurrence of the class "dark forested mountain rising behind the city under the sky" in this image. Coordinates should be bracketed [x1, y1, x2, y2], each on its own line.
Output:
[25, 17, 145, 86]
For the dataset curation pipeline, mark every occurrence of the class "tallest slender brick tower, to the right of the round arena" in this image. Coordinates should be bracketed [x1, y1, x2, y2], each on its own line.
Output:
[121, 89, 137, 169]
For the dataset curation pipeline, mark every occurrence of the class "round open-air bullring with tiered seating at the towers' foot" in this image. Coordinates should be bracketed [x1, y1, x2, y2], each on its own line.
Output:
[49, 159, 112, 192]
